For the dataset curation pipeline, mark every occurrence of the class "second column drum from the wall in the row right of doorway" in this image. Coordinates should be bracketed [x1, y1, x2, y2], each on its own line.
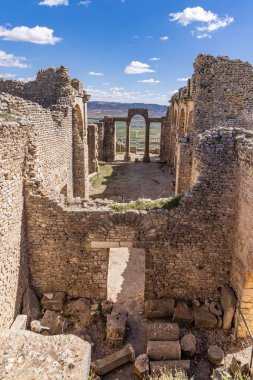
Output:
[147, 323, 179, 341]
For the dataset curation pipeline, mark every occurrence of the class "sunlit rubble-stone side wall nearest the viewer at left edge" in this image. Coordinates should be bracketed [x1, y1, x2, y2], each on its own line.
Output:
[0, 121, 31, 328]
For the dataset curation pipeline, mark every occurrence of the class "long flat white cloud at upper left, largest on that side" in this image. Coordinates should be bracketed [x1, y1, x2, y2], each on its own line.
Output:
[0, 26, 62, 45]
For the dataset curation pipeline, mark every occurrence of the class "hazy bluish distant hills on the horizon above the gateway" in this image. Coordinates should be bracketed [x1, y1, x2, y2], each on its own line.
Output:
[88, 101, 168, 118]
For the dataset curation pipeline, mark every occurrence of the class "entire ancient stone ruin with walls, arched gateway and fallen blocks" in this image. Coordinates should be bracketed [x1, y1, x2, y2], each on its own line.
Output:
[0, 55, 253, 380]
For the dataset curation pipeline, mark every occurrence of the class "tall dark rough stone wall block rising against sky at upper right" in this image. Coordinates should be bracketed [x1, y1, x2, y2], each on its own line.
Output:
[193, 55, 253, 131]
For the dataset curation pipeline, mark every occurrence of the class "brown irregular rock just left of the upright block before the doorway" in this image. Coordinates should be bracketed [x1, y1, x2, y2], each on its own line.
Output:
[64, 298, 91, 327]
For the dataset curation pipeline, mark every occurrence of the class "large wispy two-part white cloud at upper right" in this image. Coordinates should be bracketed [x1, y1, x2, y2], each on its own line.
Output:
[170, 7, 234, 39]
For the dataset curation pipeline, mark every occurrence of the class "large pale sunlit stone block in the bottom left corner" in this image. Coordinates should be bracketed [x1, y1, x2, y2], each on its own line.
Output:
[0, 330, 91, 380]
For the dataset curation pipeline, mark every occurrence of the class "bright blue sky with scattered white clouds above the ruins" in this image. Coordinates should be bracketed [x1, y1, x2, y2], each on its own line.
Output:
[0, 0, 253, 104]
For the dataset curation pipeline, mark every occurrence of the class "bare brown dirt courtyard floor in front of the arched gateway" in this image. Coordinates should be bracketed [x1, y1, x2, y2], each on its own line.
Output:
[90, 155, 174, 202]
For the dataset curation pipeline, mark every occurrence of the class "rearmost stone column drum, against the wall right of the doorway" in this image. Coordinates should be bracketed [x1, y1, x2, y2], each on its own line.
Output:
[145, 298, 175, 318]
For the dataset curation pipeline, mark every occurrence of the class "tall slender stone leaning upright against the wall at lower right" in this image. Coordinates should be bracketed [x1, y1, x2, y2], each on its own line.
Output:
[221, 286, 236, 330]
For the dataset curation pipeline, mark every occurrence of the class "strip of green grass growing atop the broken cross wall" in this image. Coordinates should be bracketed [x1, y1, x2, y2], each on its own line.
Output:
[110, 195, 182, 212]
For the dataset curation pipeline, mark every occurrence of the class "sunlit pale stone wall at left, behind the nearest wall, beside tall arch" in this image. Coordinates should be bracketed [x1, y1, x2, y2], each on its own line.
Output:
[0, 94, 72, 196]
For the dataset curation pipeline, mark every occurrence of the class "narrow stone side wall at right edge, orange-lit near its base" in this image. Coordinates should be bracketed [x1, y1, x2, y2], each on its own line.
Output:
[231, 132, 253, 329]
